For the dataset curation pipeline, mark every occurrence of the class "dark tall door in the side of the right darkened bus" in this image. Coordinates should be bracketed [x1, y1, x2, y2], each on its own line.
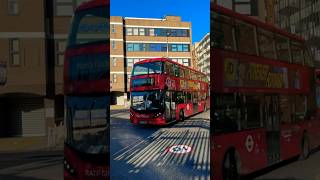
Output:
[265, 96, 280, 164]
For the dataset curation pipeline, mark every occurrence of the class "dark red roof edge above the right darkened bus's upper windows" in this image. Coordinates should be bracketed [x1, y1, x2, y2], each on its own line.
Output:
[211, 4, 304, 41]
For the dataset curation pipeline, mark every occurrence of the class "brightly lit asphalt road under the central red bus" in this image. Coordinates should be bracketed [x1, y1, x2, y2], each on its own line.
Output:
[110, 110, 210, 180]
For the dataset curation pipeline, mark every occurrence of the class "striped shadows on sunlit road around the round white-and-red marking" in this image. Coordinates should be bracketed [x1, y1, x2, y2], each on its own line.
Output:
[111, 117, 210, 179]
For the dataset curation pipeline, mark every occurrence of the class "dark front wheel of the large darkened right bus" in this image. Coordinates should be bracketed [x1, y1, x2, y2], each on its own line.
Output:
[223, 152, 240, 180]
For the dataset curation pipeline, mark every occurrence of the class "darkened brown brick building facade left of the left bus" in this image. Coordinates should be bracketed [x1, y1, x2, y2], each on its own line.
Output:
[0, 0, 80, 137]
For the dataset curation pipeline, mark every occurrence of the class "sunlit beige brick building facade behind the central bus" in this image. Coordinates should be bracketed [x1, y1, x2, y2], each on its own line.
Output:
[110, 16, 194, 105]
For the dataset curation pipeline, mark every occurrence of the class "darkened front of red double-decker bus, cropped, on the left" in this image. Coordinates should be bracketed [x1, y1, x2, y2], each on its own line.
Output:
[64, 0, 110, 179]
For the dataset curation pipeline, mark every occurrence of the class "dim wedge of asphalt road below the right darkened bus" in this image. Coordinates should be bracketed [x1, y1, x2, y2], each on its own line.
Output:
[255, 151, 320, 180]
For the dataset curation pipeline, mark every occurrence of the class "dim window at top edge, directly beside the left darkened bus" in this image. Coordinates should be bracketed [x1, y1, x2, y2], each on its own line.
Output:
[55, 0, 76, 16]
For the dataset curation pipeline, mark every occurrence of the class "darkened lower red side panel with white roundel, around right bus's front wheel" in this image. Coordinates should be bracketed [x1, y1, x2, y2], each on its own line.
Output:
[213, 129, 267, 179]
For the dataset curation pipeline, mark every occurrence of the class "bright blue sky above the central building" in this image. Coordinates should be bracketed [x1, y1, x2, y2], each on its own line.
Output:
[110, 0, 210, 42]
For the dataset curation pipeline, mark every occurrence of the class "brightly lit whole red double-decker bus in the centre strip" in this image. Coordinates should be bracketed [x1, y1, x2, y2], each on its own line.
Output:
[130, 58, 210, 125]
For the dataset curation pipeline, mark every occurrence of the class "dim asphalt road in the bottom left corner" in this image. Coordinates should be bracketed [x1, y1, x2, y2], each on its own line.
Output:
[0, 151, 63, 180]
